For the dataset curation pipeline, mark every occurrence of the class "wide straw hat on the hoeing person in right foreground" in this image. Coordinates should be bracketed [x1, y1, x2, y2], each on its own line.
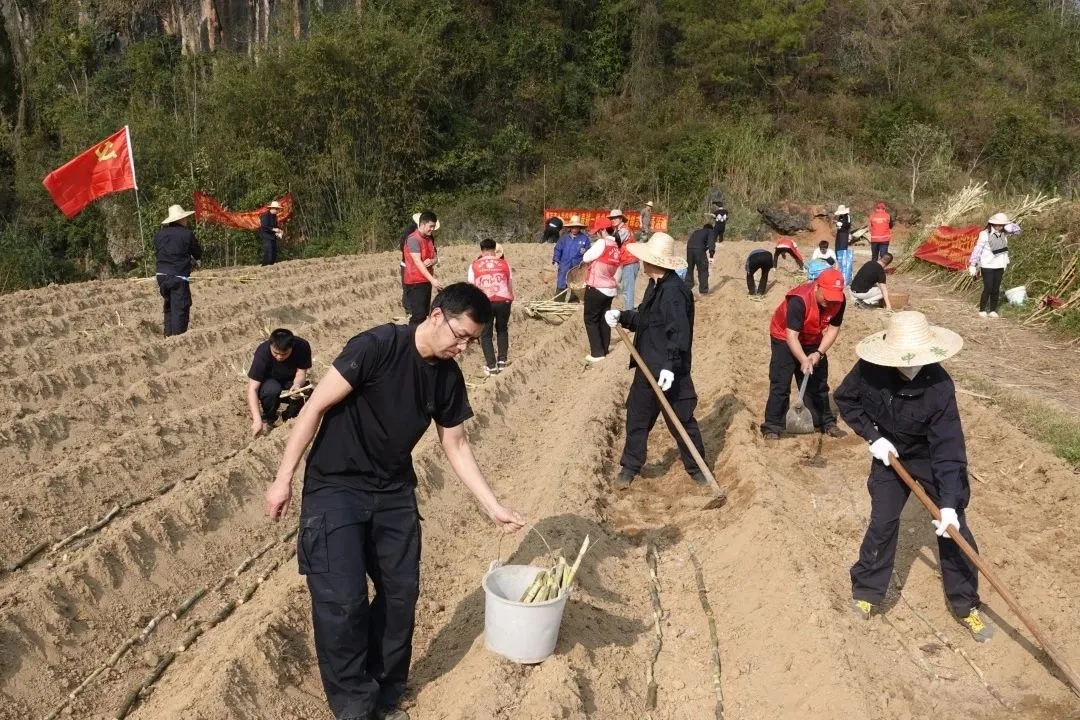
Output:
[855, 310, 963, 367]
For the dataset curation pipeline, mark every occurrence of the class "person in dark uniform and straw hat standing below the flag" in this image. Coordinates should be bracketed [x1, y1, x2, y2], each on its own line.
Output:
[153, 205, 202, 338]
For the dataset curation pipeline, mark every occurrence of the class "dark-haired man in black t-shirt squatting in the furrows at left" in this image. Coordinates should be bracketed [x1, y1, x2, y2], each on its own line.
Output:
[247, 327, 311, 438]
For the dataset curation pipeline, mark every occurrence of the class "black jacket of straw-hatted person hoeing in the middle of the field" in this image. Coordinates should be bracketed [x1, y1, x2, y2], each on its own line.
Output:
[619, 272, 693, 378]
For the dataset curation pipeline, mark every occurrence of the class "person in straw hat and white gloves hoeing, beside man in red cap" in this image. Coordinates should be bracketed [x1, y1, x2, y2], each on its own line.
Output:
[604, 232, 707, 490]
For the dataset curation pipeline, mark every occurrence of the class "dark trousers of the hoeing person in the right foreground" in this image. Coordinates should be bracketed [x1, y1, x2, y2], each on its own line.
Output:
[851, 458, 980, 617]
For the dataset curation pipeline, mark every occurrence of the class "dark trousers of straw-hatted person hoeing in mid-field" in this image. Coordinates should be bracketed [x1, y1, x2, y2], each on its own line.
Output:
[619, 370, 705, 474]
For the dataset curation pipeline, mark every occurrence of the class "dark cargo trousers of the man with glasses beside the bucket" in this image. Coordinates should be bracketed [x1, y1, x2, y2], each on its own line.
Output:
[296, 486, 420, 720]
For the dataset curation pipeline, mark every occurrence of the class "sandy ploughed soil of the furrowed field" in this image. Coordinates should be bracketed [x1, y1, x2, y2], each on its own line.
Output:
[0, 237, 1080, 720]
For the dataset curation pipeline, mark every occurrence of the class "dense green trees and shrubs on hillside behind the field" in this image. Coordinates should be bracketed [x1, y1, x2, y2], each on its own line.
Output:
[0, 0, 1080, 291]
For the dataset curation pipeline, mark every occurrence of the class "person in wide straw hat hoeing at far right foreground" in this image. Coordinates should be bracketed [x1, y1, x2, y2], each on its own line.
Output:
[834, 311, 993, 642]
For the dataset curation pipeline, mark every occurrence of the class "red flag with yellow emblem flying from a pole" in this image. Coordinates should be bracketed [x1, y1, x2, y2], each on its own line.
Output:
[42, 125, 136, 219]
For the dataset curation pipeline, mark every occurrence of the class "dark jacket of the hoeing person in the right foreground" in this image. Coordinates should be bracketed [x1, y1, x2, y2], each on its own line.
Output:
[833, 359, 969, 508]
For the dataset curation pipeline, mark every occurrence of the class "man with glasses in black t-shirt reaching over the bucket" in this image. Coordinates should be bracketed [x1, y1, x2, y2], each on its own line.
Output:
[266, 283, 525, 720]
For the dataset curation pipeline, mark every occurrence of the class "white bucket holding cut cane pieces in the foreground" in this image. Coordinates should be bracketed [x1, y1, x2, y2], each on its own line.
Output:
[483, 565, 569, 665]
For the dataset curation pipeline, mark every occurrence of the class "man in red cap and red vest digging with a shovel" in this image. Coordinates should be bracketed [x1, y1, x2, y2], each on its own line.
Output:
[761, 268, 847, 440]
